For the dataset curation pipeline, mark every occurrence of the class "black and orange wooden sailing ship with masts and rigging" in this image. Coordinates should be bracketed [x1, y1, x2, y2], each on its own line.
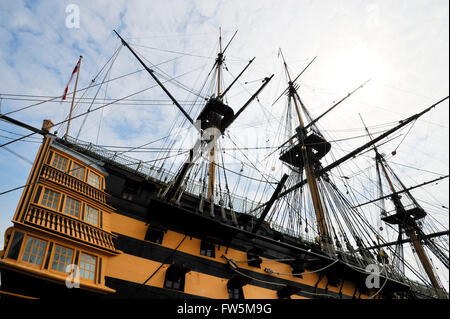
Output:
[0, 29, 448, 299]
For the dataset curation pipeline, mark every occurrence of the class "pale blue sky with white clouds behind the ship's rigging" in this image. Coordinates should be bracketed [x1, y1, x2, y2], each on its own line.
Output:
[0, 0, 449, 288]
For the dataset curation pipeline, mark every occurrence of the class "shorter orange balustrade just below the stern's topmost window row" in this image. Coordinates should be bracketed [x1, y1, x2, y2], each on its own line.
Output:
[41, 164, 107, 203]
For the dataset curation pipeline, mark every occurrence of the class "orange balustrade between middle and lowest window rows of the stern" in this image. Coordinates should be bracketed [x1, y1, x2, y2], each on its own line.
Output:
[25, 204, 117, 253]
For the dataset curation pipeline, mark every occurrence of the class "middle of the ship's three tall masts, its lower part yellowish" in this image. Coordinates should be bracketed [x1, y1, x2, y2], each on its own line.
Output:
[280, 49, 331, 252]
